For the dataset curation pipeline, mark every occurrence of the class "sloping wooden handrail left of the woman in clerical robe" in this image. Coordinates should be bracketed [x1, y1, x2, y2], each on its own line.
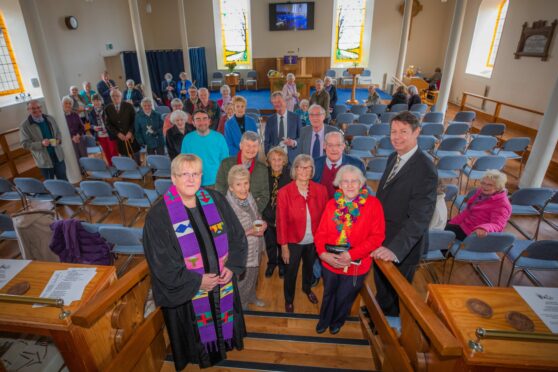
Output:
[71, 260, 149, 328]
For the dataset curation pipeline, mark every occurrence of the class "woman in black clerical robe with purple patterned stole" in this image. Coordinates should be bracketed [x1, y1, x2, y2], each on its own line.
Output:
[143, 154, 247, 370]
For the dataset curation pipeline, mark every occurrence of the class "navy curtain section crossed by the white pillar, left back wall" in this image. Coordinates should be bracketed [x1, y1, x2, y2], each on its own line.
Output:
[121, 49, 184, 97]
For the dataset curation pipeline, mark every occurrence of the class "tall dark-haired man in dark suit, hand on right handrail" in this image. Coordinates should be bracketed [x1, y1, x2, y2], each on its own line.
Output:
[371, 111, 438, 316]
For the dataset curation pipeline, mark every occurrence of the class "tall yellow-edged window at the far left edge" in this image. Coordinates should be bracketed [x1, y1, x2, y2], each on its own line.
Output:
[0, 12, 23, 96]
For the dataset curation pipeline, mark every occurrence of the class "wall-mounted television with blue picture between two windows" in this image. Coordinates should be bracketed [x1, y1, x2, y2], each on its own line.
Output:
[269, 1, 314, 31]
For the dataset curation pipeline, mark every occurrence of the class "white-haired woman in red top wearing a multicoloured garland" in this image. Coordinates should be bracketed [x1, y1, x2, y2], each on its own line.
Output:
[314, 165, 385, 334]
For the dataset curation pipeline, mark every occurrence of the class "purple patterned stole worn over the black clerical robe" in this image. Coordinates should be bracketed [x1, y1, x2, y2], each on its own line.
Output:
[164, 185, 234, 352]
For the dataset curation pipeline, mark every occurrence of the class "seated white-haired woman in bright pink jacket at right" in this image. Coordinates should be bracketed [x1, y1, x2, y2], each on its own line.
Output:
[446, 169, 512, 240]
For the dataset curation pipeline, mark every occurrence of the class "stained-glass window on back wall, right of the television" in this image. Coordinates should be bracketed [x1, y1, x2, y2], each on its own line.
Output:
[333, 0, 366, 66]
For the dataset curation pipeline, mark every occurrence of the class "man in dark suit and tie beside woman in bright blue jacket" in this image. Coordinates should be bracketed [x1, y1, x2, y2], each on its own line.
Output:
[264, 92, 302, 163]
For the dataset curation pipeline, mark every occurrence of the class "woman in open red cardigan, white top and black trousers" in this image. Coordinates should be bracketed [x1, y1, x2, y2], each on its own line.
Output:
[276, 154, 327, 313]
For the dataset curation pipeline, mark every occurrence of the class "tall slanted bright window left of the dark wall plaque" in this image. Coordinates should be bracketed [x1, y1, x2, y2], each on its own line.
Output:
[466, 0, 509, 78]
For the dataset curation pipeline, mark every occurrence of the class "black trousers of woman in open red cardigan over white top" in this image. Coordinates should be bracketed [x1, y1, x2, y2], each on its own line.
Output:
[283, 243, 316, 304]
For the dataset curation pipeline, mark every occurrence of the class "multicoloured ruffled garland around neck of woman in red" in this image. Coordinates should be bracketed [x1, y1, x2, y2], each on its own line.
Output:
[333, 187, 368, 245]
